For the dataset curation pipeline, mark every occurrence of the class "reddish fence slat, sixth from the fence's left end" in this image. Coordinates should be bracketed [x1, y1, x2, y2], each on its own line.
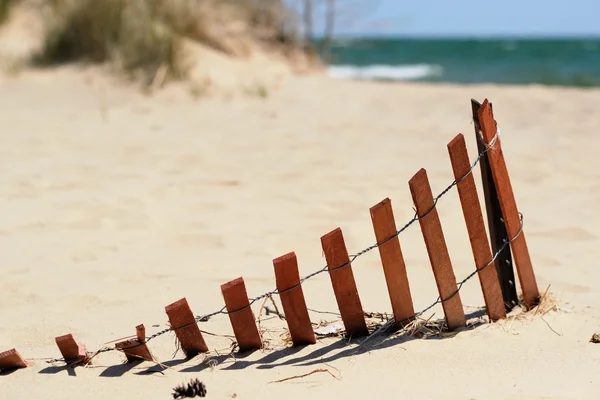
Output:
[273, 252, 317, 346]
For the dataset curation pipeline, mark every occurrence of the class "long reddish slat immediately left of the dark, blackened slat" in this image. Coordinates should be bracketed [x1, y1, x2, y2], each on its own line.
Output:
[448, 134, 506, 321]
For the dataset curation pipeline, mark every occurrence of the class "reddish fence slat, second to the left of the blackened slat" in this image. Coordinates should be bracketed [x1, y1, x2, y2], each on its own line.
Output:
[408, 168, 466, 329]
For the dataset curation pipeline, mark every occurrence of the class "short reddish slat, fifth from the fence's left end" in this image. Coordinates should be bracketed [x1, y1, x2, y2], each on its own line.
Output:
[221, 277, 262, 352]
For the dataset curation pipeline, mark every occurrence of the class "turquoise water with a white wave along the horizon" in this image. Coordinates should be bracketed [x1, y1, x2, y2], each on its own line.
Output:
[329, 39, 600, 87]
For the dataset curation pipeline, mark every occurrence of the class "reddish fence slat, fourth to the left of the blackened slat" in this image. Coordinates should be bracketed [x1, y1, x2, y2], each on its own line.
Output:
[321, 228, 369, 337]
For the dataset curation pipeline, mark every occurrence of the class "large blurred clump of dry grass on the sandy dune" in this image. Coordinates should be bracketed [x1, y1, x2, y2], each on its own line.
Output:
[32, 0, 302, 84]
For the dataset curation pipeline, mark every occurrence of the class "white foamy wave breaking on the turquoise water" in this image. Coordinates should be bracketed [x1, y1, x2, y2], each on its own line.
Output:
[328, 64, 444, 81]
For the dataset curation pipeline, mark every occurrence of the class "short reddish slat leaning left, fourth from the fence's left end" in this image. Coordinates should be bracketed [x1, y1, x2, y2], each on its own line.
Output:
[165, 297, 208, 358]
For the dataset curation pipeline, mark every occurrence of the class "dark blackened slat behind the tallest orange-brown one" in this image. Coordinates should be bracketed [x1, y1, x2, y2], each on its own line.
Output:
[471, 99, 519, 312]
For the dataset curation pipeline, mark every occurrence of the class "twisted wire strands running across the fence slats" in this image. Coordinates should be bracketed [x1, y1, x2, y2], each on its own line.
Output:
[52, 130, 523, 362]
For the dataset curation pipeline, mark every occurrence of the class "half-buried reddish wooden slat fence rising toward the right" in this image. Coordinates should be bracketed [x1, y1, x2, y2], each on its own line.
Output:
[0, 99, 539, 370]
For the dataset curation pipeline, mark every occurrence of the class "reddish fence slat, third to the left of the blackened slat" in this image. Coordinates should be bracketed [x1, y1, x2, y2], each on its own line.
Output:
[370, 198, 415, 328]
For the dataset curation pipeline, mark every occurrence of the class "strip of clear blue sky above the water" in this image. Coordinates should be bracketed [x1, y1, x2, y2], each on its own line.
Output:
[310, 0, 600, 36]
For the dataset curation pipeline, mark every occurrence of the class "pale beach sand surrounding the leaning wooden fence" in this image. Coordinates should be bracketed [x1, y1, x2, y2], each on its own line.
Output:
[0, 67, 600, 399]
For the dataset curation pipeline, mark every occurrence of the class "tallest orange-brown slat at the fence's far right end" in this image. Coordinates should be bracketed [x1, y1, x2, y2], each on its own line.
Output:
[479, 99, 540, 309]
